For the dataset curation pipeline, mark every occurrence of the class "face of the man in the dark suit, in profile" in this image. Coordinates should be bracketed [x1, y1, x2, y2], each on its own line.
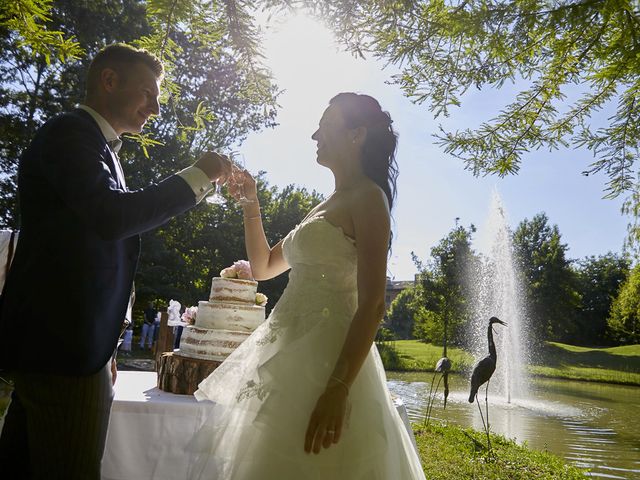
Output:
[109, 63, 160, 135]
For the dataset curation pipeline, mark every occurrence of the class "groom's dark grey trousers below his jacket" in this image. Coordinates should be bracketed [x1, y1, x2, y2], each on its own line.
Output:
[0, 361, 113, 480]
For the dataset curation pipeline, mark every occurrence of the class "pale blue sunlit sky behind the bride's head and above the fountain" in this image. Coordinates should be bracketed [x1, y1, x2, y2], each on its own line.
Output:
[239, 15, 627, 280]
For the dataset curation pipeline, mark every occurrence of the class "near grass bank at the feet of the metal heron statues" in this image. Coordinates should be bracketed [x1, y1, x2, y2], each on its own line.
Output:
[414, 424, 588, 480]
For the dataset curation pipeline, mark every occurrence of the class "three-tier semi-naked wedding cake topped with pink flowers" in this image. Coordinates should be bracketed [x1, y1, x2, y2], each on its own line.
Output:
[176, 260, 267, 362]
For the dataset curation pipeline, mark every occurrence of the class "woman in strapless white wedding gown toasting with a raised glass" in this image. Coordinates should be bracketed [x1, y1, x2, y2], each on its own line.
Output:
[188, 93, 425, 480]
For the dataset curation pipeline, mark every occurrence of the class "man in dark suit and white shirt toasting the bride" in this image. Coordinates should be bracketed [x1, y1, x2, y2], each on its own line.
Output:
[0, 44, 231, 480]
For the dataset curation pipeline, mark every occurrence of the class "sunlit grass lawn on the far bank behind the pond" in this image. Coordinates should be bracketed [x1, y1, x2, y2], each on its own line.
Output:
[382, 340, 640, 385]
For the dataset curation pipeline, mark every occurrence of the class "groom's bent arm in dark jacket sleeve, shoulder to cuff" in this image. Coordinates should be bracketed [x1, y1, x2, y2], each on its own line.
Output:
[39, 116, 228, 240]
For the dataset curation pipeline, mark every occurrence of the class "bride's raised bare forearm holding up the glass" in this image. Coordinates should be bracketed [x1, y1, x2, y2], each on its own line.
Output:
[230, 173, 289, 280]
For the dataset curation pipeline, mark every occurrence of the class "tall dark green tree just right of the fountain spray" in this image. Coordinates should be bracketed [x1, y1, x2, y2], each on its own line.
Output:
[513, 213, 580, 342]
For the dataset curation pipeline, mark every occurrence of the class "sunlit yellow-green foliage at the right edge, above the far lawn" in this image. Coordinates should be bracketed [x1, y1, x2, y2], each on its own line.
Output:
[608, 265, 640, 345]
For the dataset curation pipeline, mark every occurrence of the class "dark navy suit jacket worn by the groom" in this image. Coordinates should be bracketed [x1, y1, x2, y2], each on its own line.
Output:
[0, 110, 195, 375]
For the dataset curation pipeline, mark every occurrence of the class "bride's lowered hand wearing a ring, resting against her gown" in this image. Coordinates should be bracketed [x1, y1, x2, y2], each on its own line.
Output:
[304, 385, 348, 453]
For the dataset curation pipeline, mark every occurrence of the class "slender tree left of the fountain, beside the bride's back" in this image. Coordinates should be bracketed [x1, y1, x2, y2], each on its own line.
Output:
[413, 221, 477, 345]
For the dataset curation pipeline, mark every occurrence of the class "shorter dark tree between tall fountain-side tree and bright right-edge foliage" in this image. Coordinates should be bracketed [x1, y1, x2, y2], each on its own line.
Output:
[575, 253, 630, 345]
